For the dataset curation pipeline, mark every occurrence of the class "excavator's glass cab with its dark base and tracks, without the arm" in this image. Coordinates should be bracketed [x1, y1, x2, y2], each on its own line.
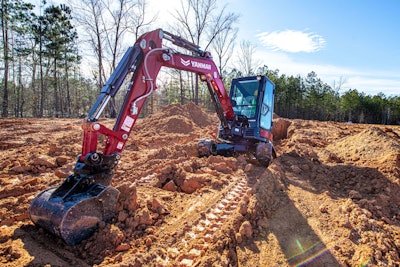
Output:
[198, 76, 275, 166]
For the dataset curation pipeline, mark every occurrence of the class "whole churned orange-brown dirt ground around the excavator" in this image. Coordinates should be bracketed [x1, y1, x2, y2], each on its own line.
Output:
[0, 104, 400, 266]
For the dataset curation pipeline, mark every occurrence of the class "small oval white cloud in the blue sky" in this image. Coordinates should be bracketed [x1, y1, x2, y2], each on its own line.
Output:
[257, 30, 326, 53]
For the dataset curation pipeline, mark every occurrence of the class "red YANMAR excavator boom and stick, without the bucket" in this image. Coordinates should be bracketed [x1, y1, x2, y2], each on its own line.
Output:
[81, 29, 234, 160]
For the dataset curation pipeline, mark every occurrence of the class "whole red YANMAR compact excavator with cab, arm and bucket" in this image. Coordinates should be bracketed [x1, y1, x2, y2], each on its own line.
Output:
[28, 29, 275, 245]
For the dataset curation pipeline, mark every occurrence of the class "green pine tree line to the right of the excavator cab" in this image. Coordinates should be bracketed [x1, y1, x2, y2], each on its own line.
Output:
[263, 67, 400, 125]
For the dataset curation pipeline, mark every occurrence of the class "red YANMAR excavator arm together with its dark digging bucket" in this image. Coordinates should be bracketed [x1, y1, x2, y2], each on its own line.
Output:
[29, 29, 235, 245]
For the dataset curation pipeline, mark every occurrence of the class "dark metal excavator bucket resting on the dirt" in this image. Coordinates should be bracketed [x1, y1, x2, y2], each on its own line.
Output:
[28, 183, 119, 245]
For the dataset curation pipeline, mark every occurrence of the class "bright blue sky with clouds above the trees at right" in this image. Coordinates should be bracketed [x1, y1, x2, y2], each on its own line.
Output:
[150, 0, 400, 96]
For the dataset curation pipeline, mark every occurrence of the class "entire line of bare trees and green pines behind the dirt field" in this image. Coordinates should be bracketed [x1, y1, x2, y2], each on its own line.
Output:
[0, 0, 400, 124]
